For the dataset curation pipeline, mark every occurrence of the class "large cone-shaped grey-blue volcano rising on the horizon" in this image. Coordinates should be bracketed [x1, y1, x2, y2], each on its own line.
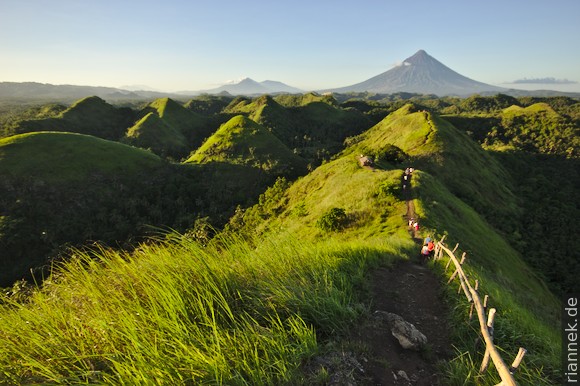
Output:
[328, 50, 507, 96]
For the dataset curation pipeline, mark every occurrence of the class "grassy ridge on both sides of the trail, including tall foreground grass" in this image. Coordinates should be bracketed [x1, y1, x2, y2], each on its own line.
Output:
[0, 105, 559, 384]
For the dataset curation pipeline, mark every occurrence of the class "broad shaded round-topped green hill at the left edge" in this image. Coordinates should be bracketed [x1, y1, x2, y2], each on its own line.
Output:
[0, 132, 164, 285]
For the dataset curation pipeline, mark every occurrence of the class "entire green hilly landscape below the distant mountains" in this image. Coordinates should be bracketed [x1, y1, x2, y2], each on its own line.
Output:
[0, 92, 580, 385]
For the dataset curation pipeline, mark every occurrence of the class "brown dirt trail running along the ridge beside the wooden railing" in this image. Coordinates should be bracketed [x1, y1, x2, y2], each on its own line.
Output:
[353, 167, 452, 386]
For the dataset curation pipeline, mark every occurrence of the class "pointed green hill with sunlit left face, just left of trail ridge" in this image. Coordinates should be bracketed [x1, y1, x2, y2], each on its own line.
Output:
[186, 115, 306, 177]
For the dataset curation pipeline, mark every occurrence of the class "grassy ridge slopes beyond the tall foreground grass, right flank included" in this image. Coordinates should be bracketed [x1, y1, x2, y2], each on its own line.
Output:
[232, 107, 560, 384]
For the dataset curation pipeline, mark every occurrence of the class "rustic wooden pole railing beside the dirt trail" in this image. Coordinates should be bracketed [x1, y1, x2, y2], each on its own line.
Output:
[433, 236, 526, 386]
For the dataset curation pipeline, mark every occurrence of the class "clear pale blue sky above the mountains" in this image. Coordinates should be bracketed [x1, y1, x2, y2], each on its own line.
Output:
[0, 0, 580, 92]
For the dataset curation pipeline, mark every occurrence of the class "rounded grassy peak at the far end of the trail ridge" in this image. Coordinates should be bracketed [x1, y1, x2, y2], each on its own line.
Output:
[356, 104, 518, 223]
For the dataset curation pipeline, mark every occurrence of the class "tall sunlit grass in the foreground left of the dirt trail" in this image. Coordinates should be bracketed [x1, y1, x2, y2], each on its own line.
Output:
[0, 234, 399, 385]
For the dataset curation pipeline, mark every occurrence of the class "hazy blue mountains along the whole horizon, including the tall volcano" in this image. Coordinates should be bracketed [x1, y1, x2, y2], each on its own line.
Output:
[0, 50, 580, 102]
